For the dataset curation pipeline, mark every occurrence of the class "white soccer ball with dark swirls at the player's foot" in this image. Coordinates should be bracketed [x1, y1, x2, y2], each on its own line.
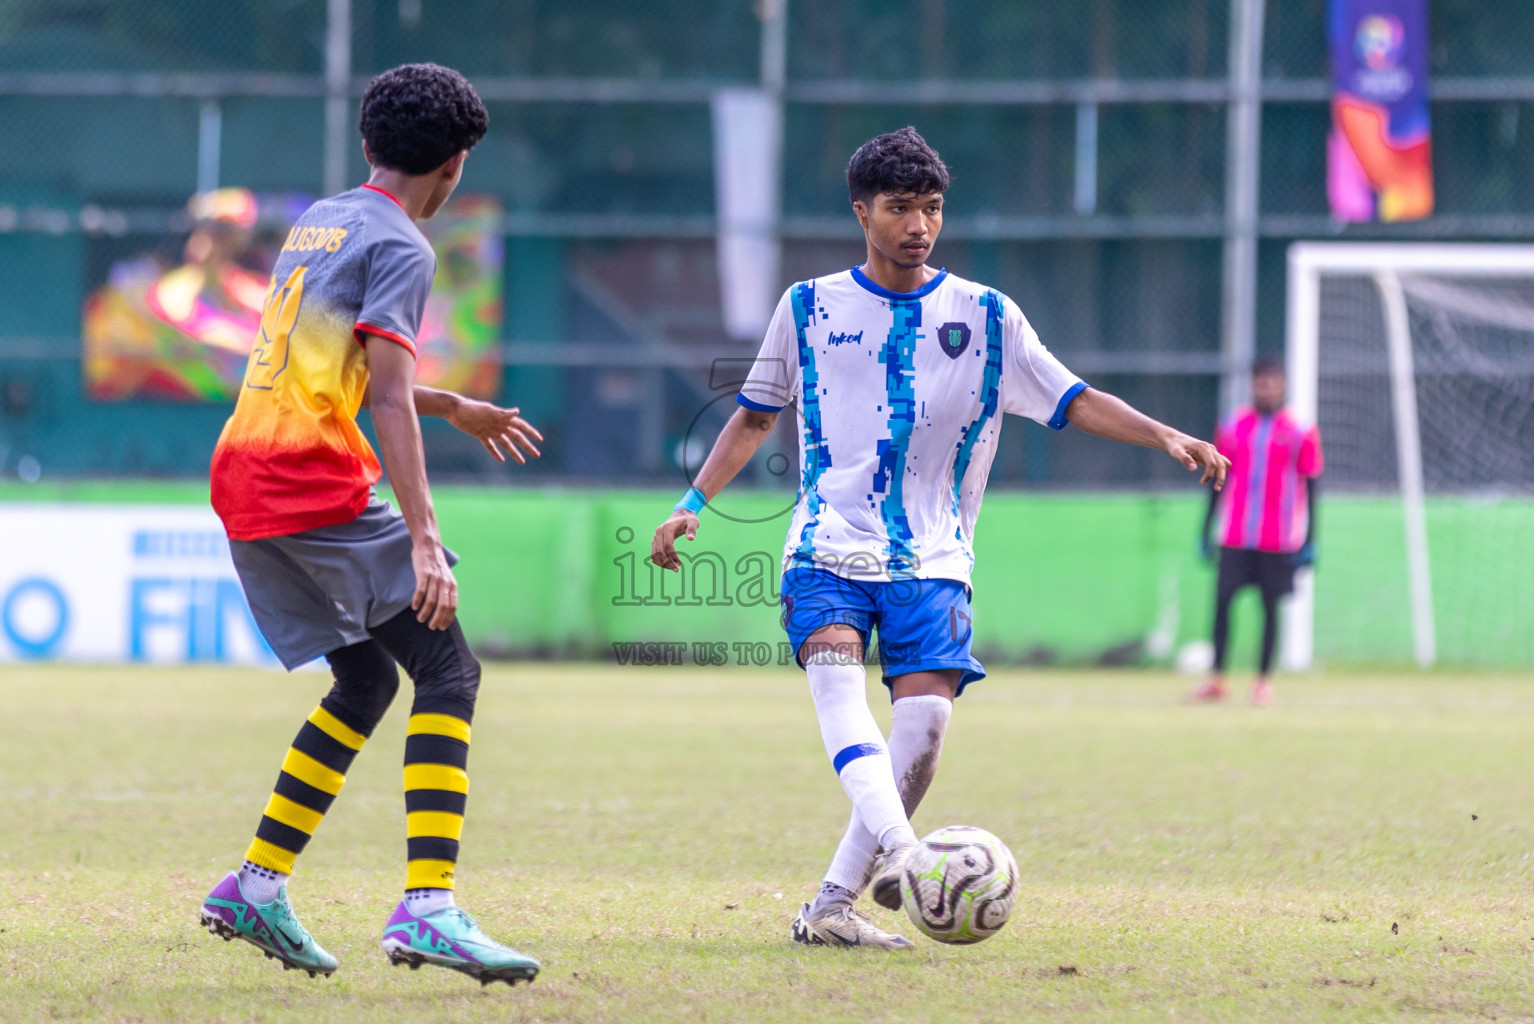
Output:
[900, 825, 1017, 946]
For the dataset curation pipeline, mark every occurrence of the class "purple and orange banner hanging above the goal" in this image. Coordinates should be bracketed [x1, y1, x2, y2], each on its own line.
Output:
[1327, 0, 1433, 221]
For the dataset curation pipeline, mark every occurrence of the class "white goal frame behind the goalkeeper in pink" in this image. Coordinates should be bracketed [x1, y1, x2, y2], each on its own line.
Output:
[1282, 242, 1534, 671]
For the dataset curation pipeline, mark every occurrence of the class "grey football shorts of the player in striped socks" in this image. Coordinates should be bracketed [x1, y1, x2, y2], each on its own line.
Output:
[229, 498, 459, 671]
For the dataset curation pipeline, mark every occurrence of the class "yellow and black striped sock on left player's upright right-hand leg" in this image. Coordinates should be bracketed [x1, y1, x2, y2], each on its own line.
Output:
[405, 705, 469, 889]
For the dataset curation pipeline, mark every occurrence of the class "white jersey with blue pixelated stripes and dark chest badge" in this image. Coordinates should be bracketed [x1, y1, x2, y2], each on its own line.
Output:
[736, 268, 1086, 584]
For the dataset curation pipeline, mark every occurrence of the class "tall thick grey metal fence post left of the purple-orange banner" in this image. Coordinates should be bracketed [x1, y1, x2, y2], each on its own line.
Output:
[1220, 0, 1264, 411]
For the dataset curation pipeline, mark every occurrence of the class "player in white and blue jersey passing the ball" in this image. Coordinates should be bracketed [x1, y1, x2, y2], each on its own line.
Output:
[650, 127, 1229, 949]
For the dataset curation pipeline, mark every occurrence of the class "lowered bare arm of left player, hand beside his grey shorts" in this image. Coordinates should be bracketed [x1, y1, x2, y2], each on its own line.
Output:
[367, 337, 459, 630]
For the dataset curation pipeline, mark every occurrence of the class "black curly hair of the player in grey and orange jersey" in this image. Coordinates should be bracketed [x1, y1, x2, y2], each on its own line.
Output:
[357, 64, 489, 175]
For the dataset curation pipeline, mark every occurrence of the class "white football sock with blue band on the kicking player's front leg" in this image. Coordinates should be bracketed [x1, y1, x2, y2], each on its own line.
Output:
[804, 650, 916, 846]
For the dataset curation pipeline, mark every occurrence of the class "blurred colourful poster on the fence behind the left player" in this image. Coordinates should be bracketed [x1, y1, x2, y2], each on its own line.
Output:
[83, 189, 505, 402]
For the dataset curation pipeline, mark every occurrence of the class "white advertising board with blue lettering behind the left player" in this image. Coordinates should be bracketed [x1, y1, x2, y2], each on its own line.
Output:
[0, 504, 276, 665]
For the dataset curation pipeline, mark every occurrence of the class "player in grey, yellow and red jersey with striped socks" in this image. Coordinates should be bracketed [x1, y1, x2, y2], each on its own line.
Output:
[201, 64, 542, 983]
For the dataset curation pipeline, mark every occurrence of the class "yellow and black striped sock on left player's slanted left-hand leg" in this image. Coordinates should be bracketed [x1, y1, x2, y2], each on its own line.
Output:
[245, 702, 367, 875]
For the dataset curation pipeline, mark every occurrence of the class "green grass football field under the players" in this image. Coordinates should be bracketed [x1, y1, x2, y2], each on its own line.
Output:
[0, 665, 1534, 1024]
